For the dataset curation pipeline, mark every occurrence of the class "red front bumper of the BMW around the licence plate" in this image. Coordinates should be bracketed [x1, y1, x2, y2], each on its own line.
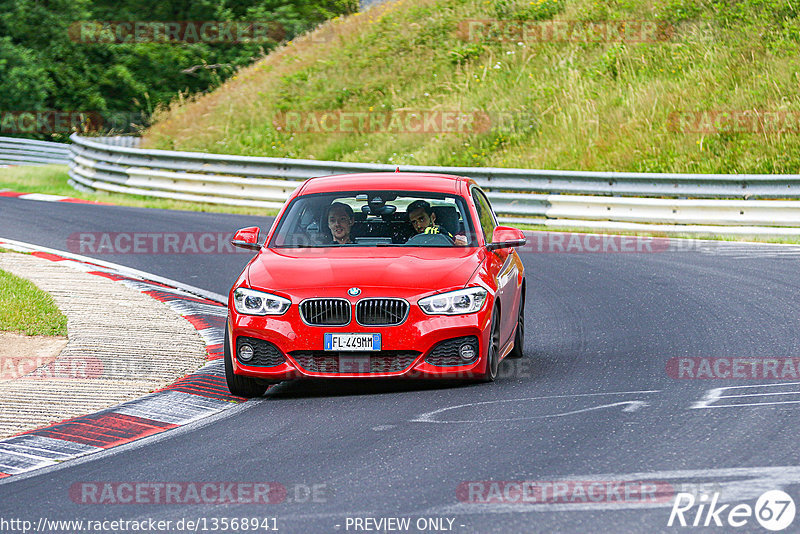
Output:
[228, 303, 491, 381]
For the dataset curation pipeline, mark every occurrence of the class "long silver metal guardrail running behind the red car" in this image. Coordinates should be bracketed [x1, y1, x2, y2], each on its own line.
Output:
[69, 135, 800, 235]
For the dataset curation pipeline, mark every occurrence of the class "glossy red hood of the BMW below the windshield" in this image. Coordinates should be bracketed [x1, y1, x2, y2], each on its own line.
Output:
[248, 247, 483, 295]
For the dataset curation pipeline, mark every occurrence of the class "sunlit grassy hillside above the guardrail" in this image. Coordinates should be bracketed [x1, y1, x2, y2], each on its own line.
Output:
[146, 0, 800, 173]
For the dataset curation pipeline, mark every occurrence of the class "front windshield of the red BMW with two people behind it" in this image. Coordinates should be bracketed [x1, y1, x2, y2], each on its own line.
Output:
[269, 191, 477, 248]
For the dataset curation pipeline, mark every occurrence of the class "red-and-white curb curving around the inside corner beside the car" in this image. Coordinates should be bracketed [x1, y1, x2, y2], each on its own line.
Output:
[0, 238, 238, 479]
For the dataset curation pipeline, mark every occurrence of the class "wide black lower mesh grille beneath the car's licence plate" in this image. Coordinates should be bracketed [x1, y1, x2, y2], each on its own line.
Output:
[289, 350, 419, 374]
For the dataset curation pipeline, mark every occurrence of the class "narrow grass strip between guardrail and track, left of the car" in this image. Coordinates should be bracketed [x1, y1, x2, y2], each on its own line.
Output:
[0, 165, 277, 215]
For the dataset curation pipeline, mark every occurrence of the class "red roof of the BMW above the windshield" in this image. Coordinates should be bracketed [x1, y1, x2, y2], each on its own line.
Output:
[300, 172, 468, 195]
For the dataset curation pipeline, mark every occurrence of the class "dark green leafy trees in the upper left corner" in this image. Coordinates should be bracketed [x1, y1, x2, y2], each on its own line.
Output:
[0, 0, 358, 140]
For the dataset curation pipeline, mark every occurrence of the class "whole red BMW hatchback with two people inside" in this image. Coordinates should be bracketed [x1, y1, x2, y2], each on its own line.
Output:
[224, 172, 525, 397]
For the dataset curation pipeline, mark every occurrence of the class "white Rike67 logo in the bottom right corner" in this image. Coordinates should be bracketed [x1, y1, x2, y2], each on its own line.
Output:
[667, 490, 795, 532]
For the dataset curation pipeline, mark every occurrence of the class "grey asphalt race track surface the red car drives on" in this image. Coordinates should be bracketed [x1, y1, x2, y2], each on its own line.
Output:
[0, 198, 800, 533]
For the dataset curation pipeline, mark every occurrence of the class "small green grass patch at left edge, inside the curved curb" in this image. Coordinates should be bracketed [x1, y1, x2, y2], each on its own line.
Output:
[0, 270, 67, 336]
